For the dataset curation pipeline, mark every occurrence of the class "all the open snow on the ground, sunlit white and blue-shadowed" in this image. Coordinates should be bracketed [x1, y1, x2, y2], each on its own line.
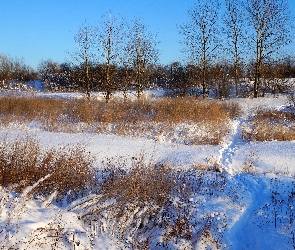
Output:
[0, 91, 295, 250]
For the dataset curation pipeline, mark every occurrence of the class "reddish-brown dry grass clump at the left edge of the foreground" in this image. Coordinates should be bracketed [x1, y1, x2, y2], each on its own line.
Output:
[0, 136, 93, 195]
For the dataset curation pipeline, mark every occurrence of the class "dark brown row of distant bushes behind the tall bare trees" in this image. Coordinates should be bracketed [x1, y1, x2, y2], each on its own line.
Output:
[0, 55, 295, 98]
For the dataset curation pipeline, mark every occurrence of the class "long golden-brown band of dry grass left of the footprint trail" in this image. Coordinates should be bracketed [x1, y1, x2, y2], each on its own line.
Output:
[0, 96, 239, 144]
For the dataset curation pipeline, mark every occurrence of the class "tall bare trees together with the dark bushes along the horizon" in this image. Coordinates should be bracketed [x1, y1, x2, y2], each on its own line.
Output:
[0, 0, 295, 101]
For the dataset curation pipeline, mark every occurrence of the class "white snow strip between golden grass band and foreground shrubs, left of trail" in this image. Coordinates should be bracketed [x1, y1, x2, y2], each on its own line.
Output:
[0, 128, 219, 171]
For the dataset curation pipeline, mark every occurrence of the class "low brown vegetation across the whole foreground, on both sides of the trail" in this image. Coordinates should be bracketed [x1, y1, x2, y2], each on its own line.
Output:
[0, 136, 295, 249]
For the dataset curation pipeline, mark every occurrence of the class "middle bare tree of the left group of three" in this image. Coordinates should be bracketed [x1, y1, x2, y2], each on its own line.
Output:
[96, 14, 125, 102]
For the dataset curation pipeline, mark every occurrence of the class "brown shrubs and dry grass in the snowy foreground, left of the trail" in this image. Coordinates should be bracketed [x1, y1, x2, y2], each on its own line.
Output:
[0, 136, 229, 249]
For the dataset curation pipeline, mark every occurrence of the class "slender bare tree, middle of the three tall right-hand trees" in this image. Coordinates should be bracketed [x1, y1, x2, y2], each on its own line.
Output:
[224, 0, 245, 97]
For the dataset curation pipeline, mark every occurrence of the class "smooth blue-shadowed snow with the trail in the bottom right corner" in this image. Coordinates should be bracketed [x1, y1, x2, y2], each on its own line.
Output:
[227, 174, 294, 250]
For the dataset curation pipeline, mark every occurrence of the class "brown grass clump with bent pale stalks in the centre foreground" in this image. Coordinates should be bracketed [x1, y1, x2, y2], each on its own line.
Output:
[81, 156, 175, 240]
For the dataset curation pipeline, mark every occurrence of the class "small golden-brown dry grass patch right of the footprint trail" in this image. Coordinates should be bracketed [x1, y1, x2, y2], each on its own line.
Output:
[243, 109, 295, 141]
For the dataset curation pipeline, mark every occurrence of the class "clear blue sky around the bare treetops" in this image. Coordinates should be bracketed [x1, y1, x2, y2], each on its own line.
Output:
[0, 0, 295, 68]
